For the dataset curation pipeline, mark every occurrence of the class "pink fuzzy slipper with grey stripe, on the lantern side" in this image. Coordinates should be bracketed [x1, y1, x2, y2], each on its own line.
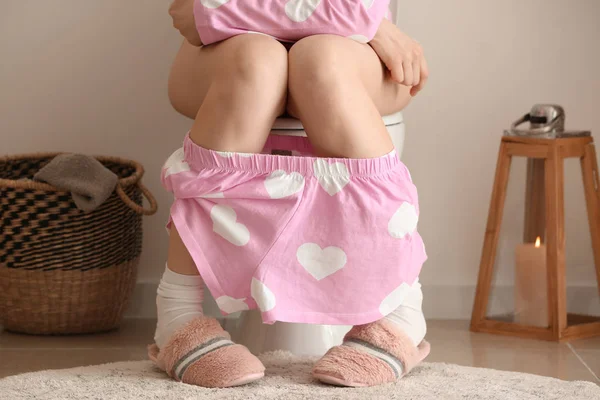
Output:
[313, 320, 430, 387]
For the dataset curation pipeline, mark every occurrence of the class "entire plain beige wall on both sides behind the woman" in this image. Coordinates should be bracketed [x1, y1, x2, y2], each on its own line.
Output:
[0, 0, 600, 317]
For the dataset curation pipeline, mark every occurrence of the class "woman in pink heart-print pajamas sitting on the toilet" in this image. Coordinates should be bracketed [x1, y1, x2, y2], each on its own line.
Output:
[149, 0, 429, 387]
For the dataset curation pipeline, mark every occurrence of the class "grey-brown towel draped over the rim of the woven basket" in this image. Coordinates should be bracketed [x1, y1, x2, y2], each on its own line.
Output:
[33, 154, 119, 212]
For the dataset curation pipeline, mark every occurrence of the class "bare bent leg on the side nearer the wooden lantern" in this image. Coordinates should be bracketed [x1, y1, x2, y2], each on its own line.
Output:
[287, 35, 411, 158]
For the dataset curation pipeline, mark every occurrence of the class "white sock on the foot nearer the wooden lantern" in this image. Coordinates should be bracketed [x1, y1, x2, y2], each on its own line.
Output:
[385, 279, 427, 346]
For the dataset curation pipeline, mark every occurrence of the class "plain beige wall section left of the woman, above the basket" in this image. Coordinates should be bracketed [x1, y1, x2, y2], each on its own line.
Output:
[0, 0, 190, 281]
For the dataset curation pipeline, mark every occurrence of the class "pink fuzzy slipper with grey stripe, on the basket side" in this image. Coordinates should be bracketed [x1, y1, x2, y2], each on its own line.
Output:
[148, 317, 265, 387]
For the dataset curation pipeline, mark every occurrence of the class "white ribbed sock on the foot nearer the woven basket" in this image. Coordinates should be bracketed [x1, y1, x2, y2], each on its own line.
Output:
[154, 266, 204, 348]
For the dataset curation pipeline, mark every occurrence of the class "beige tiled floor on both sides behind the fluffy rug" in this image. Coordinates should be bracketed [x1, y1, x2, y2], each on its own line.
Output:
[0, 320, 600, 384]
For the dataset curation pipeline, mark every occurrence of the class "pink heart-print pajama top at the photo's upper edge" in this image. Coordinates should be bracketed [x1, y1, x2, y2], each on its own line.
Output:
[194, 0, 390, 45]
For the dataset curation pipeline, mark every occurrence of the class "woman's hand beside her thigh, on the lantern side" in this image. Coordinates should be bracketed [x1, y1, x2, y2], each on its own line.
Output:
[369, 19, 429, 96]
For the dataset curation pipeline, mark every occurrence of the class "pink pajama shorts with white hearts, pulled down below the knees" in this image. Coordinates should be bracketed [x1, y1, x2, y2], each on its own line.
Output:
[162, 137, 427, 325]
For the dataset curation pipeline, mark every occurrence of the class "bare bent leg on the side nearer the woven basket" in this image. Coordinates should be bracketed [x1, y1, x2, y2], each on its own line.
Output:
[167, 34, 288, 275]
